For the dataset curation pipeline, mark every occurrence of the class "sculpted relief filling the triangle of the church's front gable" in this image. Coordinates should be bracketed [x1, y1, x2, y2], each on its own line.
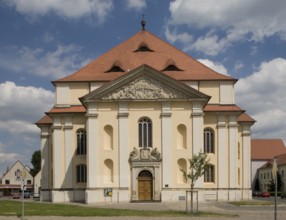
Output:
[103, 77, 187, 100]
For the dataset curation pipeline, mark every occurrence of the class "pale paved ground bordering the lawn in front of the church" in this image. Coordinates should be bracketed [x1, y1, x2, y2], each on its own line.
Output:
[0, 199, 286, 220]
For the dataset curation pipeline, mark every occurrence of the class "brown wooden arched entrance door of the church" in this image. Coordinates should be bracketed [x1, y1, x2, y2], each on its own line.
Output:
[138, 170, 153, 201]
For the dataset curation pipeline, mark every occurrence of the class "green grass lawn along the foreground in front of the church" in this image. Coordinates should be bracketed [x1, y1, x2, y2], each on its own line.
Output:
[0, 200, 236, 217]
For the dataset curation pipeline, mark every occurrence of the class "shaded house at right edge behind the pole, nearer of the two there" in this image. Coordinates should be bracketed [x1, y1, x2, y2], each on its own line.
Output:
[258, 154, 286, 192]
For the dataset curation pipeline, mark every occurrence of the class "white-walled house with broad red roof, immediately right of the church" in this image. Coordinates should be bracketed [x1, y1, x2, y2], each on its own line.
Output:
[251, 139, 286, 190]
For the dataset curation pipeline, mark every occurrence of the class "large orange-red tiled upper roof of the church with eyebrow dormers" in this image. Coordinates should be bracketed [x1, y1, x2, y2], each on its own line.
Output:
[54, 31, 236, 83]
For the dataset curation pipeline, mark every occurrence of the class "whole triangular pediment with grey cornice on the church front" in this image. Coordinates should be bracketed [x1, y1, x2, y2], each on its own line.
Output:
[81, 65, 209, 103]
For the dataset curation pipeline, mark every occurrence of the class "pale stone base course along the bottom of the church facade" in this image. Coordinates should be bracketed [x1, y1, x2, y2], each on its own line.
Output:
[41, 188, 252, 204]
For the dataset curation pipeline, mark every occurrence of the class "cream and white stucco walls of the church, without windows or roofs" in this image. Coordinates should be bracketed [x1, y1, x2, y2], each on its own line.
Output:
[41, 72, 250, 203]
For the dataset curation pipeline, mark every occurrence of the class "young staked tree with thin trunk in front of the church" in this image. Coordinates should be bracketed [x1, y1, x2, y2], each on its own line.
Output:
[181, 152, 210, 213]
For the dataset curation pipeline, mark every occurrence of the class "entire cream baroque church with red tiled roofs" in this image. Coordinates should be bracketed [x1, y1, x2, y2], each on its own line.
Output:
[36, 26, 255, 203]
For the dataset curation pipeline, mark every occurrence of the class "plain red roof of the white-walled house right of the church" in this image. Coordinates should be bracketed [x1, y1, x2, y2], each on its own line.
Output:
[251, 139, 286, 160]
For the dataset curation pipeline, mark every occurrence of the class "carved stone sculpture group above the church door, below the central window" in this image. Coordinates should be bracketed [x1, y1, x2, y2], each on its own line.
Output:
[129, 147, 162, 162]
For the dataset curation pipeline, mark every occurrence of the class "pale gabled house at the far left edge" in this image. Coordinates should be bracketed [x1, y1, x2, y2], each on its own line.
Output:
[0, 160, 33, 196]
